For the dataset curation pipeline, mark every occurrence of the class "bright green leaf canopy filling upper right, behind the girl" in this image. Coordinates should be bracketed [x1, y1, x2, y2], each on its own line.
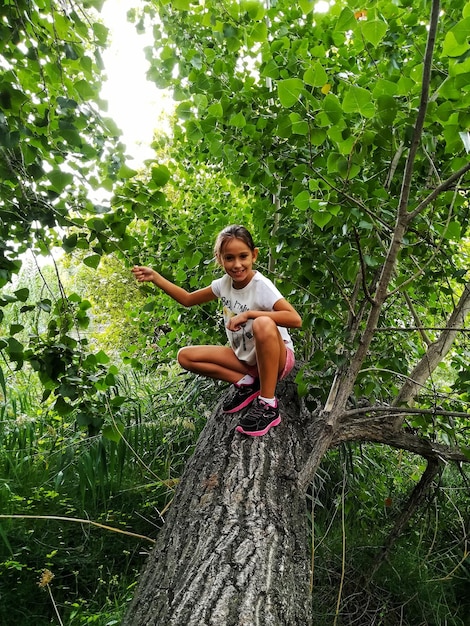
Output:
[130, 1, 468, 412]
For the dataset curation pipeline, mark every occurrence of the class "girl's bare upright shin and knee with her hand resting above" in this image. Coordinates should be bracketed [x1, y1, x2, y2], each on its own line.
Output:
[253, 317, 286, 398]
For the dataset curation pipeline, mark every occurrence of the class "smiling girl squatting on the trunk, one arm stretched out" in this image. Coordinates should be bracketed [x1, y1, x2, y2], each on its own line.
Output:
[132, 225, 302, 437]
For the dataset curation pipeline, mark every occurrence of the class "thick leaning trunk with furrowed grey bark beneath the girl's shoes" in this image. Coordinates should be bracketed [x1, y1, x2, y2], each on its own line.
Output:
[124, 382, 311, 626]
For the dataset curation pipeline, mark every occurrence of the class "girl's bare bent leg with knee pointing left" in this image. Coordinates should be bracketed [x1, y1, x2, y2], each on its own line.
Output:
[178, 346, 249, 383]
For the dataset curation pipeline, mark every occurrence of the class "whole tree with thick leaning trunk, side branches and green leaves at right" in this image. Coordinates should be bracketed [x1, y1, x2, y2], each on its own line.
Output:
[123, 0, 470, 624]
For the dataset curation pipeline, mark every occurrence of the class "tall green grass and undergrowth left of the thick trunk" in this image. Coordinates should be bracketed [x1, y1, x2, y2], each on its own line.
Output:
[0, 372, 217, 626]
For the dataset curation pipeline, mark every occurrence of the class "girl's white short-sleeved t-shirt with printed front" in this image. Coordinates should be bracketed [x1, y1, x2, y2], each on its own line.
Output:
[211, 272, 294, 365]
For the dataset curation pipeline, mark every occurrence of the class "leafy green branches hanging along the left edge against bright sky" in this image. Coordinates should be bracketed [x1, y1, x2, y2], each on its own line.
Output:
[0, 0, 136, 430]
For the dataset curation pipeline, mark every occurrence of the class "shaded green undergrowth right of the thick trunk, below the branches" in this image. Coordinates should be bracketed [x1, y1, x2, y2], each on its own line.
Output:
[308, 445, 470, 626]
